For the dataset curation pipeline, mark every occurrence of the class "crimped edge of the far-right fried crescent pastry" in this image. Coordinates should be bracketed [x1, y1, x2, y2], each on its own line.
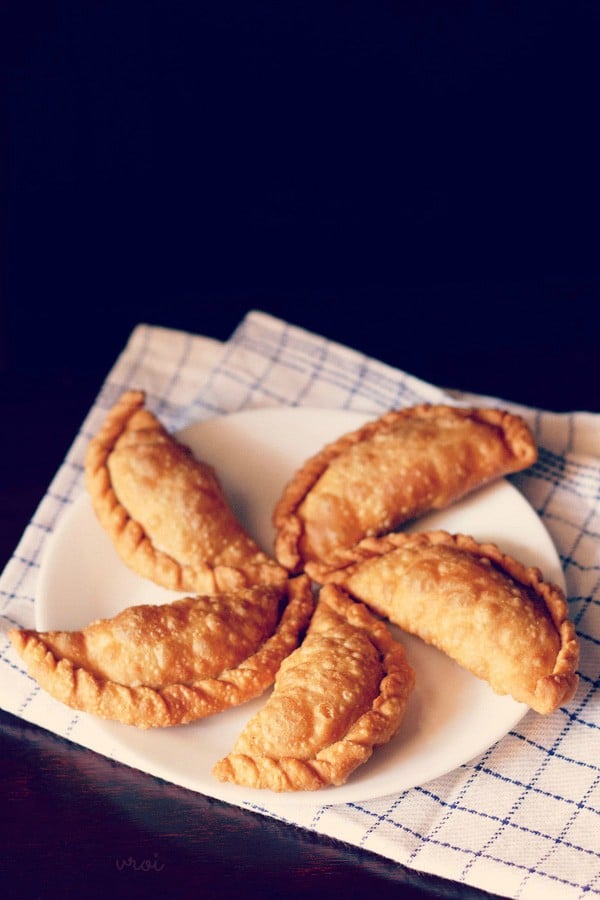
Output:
[306, 530, 579, 715]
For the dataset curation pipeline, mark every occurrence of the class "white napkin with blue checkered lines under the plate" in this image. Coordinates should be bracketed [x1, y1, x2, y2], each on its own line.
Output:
[0, 312, 600, 900]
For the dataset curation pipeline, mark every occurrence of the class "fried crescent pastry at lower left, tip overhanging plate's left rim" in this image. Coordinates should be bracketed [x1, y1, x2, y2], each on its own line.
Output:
[9, 576, 314, 728]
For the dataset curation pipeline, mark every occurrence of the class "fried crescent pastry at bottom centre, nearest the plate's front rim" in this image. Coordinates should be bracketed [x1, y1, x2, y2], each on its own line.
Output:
[213, 585, 414, 791]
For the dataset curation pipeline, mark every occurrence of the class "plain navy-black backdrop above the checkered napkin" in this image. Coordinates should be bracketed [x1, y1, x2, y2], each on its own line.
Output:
[0, 0, 600, 409]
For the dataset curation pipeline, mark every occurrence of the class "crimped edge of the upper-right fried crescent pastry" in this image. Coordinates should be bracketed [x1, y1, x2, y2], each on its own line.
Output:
[272, 403, 538, 573]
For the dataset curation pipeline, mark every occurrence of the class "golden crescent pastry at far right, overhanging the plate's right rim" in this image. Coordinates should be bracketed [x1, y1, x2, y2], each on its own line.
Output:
[316, 531, 579, 714]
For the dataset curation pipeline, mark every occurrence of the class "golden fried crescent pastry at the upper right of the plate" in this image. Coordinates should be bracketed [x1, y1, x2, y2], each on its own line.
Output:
[273, 404, 537, 572]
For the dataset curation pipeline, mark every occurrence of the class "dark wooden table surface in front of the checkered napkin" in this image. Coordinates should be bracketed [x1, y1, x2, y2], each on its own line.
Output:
[0, 713, 496, 898]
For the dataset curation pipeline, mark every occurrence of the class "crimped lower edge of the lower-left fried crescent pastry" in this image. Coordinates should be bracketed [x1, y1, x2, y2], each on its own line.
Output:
[8, 575, 314, 729]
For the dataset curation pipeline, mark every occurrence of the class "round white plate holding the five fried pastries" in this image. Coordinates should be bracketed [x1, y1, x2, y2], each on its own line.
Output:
[36, 407, 564, 808]
